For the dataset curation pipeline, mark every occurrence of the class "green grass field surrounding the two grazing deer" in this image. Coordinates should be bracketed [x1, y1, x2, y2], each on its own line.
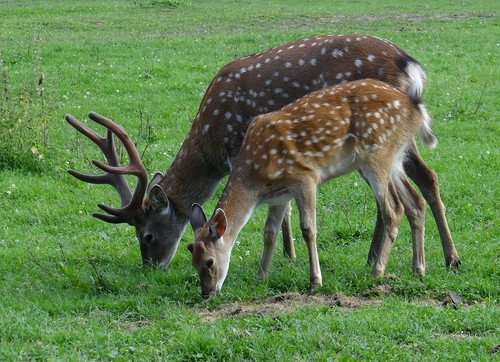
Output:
[0, 0, 500, 361]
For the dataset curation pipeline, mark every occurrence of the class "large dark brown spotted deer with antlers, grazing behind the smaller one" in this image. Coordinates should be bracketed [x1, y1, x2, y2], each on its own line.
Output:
[66, 34, 459, 271]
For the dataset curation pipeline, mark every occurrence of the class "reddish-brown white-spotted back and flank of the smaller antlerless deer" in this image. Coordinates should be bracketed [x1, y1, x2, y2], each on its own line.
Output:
[230, 79, 434, 190]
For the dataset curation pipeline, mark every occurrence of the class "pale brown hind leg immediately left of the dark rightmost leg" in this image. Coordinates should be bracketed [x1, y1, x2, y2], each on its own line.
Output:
[394, 173, 425, 275]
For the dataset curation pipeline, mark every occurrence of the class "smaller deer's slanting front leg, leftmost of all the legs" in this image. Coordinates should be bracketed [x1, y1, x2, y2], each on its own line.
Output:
[256, 203, 290, 279]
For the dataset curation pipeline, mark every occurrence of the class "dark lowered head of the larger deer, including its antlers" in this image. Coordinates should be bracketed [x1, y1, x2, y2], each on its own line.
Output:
[65, 112, 185, 266]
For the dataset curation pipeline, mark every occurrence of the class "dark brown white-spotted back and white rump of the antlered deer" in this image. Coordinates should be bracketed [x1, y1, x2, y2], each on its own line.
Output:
[174, 34, 425, 173]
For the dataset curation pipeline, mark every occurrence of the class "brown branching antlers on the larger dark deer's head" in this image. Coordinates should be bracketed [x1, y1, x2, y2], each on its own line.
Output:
[64, 112, 148, 224]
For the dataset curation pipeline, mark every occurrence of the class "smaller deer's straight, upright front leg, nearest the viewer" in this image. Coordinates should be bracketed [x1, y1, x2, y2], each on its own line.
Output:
[294, 180, 323, 292]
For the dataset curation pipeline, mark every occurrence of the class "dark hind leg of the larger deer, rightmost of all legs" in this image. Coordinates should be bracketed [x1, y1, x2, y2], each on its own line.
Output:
[403, 141, 460, 268]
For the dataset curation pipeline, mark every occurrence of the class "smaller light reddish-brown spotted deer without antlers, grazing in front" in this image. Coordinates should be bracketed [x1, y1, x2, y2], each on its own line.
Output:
[188, 79, 436, 297]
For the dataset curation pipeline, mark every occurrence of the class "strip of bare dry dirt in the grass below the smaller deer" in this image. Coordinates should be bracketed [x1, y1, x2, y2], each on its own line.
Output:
[200, 293, 381, 322]
